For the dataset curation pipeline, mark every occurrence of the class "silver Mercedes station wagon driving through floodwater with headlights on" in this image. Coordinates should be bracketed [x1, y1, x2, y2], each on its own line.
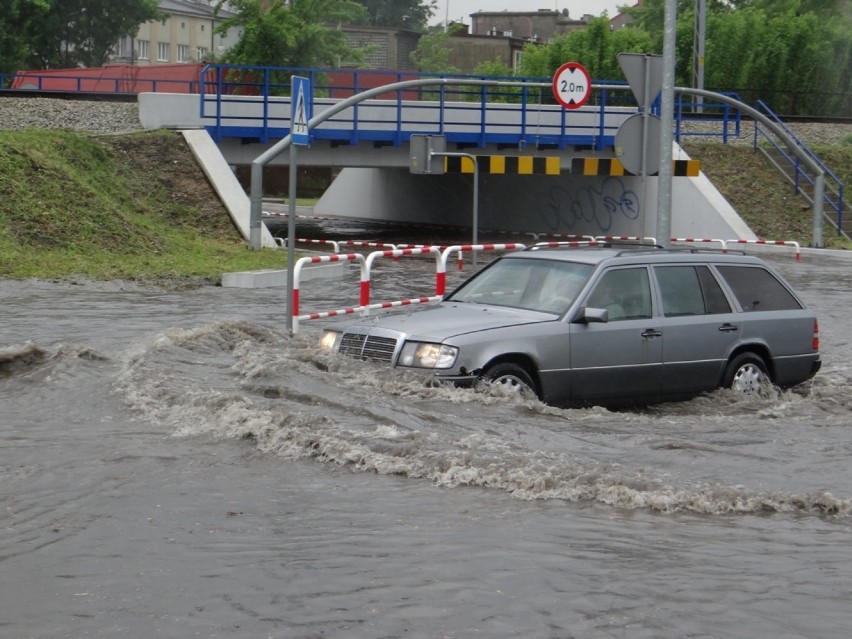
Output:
[321, 246, 821, 406]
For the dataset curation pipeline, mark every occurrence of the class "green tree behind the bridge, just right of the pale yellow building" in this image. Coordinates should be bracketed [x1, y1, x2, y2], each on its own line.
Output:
[216, 0, 365, 67]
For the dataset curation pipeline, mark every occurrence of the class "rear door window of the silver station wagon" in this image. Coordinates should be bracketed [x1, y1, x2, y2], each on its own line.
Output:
[654, 266, 731, 317]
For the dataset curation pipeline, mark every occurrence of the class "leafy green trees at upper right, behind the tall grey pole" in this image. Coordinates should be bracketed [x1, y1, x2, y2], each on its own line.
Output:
[521, 0, 852, 115]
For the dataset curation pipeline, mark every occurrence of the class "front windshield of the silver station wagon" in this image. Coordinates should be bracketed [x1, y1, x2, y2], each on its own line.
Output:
[447, 258, 593, 314]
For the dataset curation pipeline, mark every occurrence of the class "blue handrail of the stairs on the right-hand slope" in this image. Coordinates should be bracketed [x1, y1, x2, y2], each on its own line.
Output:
[754, 100, 845, 235]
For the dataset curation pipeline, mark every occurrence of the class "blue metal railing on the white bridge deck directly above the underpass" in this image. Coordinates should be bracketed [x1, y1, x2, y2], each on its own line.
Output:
[200, 65, 637, 150]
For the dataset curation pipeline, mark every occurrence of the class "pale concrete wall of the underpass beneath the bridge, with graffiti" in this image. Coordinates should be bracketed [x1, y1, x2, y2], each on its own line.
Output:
[314, 168, 756, 239]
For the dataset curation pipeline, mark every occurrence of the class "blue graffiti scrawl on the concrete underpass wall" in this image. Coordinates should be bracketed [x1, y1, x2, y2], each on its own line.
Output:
[535, 177, 641, 234]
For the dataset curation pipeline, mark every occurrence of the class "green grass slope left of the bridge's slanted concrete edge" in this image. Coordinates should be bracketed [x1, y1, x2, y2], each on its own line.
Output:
[0, 129, 284, 283]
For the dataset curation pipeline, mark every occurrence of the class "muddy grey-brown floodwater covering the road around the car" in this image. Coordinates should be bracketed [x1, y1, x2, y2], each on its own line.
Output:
[0, 251, 852, 639]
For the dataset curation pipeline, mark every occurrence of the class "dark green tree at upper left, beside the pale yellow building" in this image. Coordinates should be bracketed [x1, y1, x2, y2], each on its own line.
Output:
[30, 0, 159, 69]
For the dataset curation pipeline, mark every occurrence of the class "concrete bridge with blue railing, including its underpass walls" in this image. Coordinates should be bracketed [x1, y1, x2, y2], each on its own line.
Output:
[140, 71, 756, 246]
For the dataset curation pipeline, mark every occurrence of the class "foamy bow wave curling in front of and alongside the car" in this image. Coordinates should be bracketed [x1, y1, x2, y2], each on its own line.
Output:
[118, 322, 852, 517]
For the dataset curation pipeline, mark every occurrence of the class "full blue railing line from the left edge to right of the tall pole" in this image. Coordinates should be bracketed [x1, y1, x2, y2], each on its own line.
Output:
[0, 64, 756, 150]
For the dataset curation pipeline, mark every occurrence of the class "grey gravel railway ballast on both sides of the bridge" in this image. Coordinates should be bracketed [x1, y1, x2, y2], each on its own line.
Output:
[0, 96, 852, 146]
